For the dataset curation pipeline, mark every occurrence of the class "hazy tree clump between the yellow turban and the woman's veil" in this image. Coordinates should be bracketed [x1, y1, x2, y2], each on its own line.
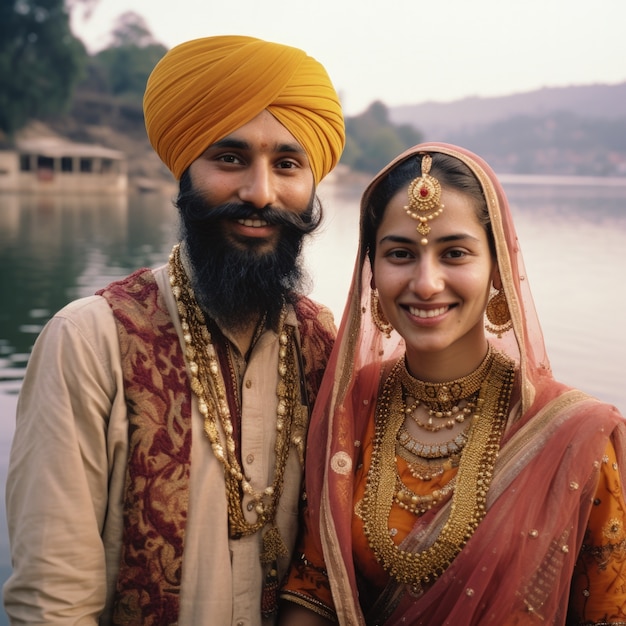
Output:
[341, 101, 421, 174]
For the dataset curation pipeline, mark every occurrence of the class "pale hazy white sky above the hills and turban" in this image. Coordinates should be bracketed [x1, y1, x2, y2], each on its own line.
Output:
[72, 0, 626, 115]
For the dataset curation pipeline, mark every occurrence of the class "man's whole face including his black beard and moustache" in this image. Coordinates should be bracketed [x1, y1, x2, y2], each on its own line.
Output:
[177, 113, 319, 330]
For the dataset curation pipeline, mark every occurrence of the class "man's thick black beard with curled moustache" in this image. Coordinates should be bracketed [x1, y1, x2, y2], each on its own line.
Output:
[176, 174, 321, 331]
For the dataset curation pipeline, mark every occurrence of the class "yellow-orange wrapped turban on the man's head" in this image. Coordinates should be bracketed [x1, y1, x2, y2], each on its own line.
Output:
[143, 36, 345, 183]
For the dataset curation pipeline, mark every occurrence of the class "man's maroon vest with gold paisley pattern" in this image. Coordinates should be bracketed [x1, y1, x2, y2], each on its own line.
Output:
[98, 269, 335, 626]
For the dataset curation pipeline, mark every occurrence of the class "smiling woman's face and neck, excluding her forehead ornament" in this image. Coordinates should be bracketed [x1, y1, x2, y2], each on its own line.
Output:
[373, 180, 495, 376]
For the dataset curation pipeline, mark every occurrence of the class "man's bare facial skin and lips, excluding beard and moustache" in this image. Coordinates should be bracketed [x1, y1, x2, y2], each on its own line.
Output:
[184, 111, 314, 252]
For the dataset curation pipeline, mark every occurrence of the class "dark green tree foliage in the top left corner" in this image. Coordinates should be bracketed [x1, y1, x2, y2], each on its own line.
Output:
[0, 0, 87, 136]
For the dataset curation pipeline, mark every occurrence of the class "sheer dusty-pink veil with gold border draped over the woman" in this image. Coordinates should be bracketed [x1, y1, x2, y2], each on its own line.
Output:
[306, 143, 624, 624]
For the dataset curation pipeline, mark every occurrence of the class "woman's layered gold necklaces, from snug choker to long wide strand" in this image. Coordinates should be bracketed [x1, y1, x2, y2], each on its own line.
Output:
[360, 348, 515, 588]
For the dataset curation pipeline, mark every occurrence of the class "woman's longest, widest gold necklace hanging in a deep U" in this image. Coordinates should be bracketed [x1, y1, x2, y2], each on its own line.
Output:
[361, 351, 515, 589]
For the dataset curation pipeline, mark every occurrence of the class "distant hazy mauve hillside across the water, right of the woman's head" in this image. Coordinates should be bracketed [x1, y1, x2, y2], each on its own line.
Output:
[389, 83, 626, 176]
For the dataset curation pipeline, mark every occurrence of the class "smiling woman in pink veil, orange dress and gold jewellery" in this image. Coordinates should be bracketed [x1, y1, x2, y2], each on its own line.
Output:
[281, 144, 626, 626]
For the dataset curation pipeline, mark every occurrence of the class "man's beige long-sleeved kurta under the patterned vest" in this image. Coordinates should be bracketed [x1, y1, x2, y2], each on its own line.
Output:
[4, 266, 308, 626]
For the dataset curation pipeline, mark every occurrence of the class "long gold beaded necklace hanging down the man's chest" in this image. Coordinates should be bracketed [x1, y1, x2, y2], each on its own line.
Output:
[169, 244, 298, 540]
